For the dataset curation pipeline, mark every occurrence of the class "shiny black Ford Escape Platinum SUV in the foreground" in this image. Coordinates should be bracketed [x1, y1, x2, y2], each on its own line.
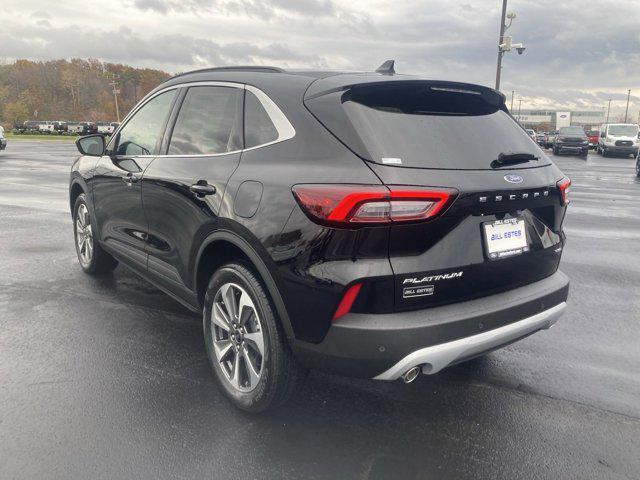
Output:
[70, 65, 570, 411]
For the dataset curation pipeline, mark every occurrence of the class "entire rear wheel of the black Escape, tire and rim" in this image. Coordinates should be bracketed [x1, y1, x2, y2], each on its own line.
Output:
[203, 263, 305, 413]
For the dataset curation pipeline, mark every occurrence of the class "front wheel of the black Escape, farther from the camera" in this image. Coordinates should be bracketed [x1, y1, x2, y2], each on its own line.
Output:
[73, 193, 118, 274]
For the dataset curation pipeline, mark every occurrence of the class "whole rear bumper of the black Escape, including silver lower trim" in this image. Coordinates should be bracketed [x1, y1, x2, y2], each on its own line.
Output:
[293, 271, 569, 380]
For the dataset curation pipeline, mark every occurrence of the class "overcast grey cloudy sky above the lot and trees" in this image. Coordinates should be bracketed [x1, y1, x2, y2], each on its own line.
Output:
[0, 0, 640, 118]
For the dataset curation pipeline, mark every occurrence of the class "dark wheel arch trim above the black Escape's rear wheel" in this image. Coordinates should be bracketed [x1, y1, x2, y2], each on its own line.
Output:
[193, 230, 295, 342]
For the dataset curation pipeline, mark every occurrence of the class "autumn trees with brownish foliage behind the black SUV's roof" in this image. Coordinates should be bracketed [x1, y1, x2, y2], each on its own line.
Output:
[0, 59, 169, 126]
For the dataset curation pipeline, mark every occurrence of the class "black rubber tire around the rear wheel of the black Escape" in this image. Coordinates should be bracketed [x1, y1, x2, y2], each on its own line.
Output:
[203, 262, 306, 413]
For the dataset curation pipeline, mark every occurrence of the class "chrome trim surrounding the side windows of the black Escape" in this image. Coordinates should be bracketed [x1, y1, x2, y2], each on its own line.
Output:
[106, 81, 296, 158]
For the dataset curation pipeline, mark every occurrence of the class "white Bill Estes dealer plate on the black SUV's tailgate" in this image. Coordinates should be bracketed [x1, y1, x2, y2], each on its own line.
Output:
[482, 217, 529, 260]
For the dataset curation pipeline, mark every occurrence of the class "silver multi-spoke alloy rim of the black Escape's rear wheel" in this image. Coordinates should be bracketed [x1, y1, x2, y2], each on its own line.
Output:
[211, 283, 264, 392]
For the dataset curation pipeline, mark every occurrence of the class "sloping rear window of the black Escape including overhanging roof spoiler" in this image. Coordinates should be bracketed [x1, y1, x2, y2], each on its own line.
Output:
[306, 82, 549, 170]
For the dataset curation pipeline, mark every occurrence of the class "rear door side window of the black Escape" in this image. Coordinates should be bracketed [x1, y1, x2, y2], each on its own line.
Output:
[169, 86, 243, 155]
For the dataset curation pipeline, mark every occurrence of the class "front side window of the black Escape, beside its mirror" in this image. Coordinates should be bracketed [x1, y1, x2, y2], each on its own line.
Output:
[116, 90, 177, 156]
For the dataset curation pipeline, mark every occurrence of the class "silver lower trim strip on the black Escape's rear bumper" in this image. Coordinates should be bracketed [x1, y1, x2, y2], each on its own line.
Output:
[374, 302, 567, 380]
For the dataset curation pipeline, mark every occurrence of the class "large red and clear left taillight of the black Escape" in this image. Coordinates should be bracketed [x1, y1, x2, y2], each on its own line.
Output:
[293, 185, 457, 226]
